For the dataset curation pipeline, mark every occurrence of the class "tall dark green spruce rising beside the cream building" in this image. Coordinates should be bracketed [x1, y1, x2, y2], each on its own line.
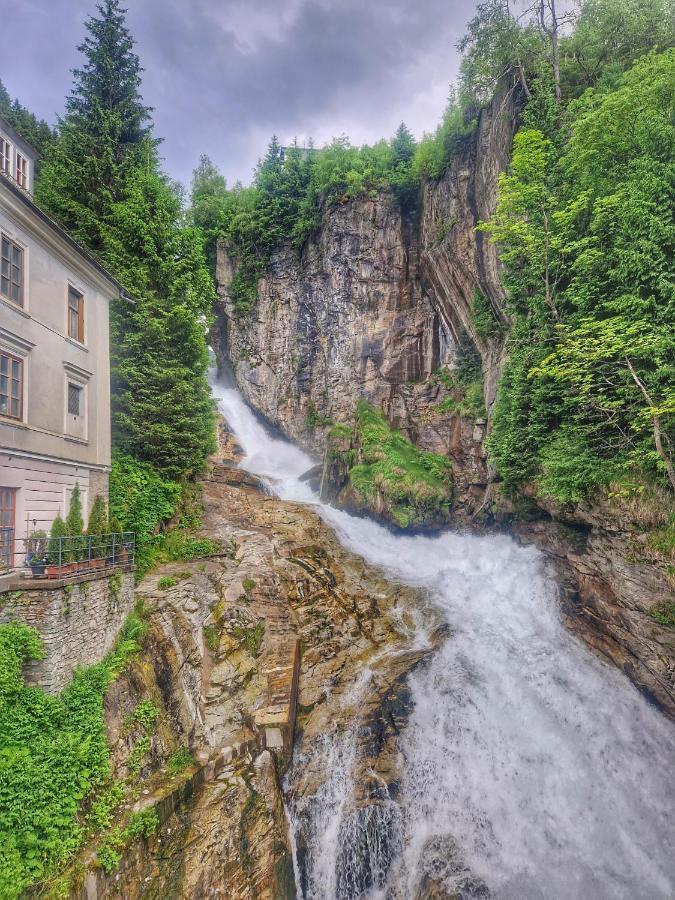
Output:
[38, 0, 215, 479]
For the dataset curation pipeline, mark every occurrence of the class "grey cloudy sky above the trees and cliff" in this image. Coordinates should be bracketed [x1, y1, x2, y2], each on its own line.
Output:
[0, 0, 475, 184]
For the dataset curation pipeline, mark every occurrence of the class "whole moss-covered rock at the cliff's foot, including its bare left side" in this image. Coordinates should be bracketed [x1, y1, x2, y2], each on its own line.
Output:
[322, 400, 452, 528]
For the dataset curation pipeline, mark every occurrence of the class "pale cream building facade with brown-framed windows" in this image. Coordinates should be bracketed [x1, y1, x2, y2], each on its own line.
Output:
[0, 119, 122, 563]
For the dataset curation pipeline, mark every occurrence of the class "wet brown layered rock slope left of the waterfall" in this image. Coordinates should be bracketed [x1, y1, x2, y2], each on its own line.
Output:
[56, 428, 441, 900]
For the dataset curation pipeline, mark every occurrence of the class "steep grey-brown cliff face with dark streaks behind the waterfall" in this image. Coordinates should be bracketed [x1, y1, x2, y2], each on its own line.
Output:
[215, 92, 517, 515]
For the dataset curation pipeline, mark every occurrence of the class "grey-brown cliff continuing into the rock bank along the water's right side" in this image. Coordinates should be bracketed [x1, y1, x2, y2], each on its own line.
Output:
[209, 86, 675, 714]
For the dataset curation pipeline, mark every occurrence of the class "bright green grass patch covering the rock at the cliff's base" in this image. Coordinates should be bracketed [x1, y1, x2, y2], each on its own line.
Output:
[349, 400, 452, 528]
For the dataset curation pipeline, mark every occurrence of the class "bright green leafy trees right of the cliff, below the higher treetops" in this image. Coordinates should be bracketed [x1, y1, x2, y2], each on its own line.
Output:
[483, 50, 675, 502]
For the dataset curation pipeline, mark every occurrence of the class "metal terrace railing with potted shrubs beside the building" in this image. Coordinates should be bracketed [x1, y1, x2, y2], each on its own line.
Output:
[0, 527, 136, 578]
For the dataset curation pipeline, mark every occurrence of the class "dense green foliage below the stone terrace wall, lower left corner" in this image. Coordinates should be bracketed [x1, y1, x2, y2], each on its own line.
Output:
[0, 616, 146, 898]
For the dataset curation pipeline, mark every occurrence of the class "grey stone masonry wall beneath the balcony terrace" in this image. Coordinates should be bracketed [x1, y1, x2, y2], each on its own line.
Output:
[0, 571, 134, 694]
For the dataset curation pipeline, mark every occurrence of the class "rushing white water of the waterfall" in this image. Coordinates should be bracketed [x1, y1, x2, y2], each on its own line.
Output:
[214, 374, 675, 900]
